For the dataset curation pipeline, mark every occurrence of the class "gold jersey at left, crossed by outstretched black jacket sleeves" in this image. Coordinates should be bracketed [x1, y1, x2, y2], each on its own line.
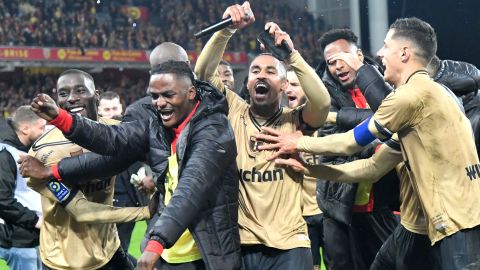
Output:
[29, 118, 120, 270]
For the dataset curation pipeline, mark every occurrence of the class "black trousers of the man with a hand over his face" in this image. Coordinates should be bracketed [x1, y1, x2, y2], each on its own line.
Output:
[323, 209, 398, 270]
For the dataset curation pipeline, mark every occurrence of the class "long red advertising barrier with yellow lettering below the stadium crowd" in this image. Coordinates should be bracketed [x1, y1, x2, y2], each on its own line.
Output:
[0, 46, 248, 64]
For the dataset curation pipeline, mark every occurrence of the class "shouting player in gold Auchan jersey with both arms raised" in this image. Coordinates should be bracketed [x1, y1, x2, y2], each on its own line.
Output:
[195, 2, 330, 269]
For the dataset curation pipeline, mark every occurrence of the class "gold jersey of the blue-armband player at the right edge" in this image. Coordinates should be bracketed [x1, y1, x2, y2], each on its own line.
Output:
[376, 72, 480, 244]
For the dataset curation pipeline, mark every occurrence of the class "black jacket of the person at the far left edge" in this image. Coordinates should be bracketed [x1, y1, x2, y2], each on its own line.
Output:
[0, 122, 40, 248]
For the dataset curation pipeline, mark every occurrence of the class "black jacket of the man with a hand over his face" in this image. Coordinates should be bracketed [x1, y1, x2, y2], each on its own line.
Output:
[317, 61, 399, 225]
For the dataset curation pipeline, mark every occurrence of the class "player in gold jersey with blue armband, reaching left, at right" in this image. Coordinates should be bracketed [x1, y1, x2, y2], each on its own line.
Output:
[258, 18, 480, 269]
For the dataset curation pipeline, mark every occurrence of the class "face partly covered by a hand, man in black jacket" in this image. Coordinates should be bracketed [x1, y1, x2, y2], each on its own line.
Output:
[324, 39, 363, 89]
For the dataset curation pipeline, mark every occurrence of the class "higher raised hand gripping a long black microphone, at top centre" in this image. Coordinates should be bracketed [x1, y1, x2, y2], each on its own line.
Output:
[195, 1, 255, 38]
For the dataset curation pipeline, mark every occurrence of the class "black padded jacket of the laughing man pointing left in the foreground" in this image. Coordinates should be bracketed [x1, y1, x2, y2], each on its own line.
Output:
[59, 82, 241, 270]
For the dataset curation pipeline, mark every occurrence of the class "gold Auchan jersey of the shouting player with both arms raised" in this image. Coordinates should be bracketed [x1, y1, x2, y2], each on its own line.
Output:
[195, 29, 330, 249]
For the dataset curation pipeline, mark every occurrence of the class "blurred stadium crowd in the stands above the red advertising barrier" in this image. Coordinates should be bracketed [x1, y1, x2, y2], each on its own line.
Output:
[0, 0, 325, 61]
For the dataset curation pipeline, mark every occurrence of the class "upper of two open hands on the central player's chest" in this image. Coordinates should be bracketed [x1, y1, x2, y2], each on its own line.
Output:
[255, 127, 303, 160]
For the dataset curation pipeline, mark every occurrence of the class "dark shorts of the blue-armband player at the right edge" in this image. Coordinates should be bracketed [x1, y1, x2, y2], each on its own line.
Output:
[432, 226, 480, 270]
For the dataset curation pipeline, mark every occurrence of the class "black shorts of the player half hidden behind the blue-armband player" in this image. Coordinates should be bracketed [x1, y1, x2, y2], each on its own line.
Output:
[370, 224, 436, 270]
